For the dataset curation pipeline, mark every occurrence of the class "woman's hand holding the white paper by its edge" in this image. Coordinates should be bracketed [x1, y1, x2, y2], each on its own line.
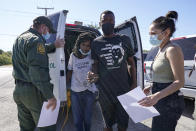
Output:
[138, 93, 159, 107]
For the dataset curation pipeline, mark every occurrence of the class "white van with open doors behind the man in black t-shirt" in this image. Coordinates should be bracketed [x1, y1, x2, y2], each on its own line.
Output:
[47, 10, 143, 101]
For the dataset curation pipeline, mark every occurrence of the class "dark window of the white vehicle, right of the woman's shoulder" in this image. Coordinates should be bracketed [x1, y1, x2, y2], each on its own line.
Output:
[172, 37, 196, 60]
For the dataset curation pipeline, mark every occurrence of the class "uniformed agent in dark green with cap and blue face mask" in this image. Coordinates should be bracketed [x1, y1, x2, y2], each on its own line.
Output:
[12, 16, 65, 131]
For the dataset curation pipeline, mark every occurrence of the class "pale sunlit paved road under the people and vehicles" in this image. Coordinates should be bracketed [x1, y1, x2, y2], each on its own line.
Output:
[0, 66, 194, 131]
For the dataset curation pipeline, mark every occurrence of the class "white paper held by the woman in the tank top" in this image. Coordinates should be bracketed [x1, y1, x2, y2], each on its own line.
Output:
[118, 87, 160, 123]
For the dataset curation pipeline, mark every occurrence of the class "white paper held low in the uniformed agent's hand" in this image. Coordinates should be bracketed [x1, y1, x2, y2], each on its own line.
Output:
[37, 101, 60, 127]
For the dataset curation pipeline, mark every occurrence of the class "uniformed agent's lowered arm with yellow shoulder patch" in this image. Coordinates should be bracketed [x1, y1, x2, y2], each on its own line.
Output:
[27, 40, 56, 110]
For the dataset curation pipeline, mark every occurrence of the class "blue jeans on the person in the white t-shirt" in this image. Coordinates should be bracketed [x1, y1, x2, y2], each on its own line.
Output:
[71, 90, 95, 131]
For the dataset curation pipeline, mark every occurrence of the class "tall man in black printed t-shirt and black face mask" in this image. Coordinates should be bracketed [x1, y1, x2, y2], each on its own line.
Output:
[88, 11, 136, 131]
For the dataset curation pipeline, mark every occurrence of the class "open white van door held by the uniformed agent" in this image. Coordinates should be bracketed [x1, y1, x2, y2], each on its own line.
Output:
[46, 11, 68, 101]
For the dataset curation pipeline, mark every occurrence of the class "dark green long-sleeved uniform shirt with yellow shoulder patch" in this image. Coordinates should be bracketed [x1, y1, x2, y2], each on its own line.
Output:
[12, 28, 55, 99]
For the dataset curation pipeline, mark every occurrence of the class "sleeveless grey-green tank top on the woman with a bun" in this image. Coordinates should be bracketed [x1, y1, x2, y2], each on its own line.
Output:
[152, 43, 174, 83]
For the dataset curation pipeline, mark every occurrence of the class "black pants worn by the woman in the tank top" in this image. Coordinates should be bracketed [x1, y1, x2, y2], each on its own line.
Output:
[152, 83, 185, 131]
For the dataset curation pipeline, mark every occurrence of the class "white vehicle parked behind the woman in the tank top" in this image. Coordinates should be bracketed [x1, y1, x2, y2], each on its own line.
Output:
[144, 35, 196, 98]
